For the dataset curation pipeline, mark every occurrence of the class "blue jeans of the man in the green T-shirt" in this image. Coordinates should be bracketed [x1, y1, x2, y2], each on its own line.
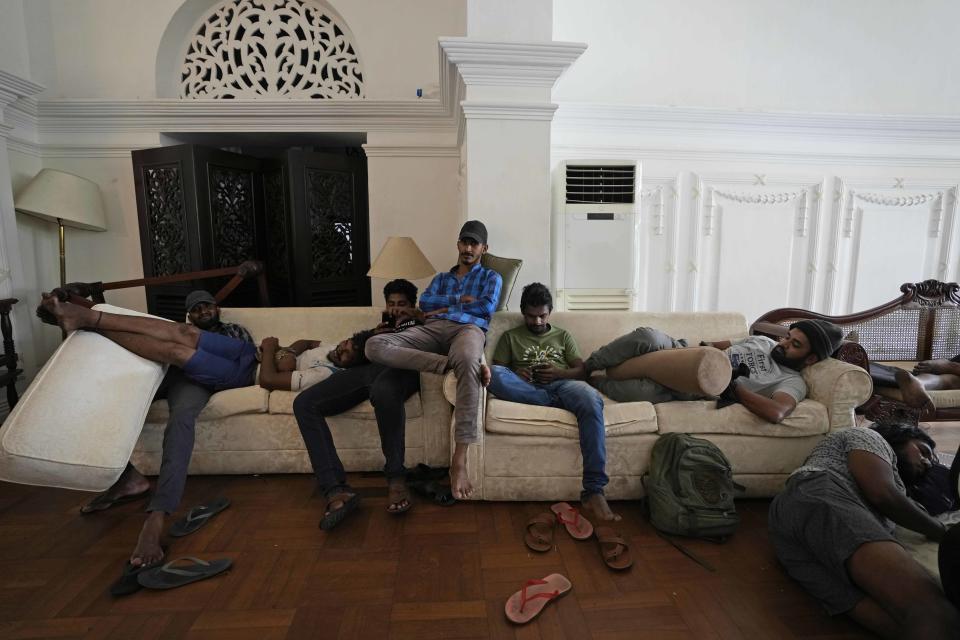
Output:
[488, 365, 609, 498]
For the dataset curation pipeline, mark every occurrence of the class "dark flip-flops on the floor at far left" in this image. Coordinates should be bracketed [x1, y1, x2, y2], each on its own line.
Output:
[98, 498, 233, 597]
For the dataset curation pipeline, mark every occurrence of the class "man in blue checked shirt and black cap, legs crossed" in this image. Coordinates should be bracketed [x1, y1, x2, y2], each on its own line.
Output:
[366, 220, 503, 499]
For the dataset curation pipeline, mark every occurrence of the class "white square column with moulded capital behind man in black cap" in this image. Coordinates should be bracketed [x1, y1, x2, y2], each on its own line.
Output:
[440, 38, 586, 309]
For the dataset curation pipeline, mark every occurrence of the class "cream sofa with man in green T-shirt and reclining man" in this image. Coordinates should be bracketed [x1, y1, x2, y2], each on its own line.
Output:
[444, 311, 873, 500]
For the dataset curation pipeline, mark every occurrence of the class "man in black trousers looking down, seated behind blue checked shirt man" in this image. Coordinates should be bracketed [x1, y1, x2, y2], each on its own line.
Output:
[284, 280, 420, 530]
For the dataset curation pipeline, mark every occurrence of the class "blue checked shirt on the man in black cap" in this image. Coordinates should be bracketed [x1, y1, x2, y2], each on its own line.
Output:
[420, 263, 503, 331]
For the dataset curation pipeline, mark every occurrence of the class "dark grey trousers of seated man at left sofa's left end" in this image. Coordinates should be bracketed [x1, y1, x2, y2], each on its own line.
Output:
[147, 366, 213, 514]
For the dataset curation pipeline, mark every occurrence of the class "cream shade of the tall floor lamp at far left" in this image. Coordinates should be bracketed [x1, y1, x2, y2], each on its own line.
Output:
[14, 169, 107, 231]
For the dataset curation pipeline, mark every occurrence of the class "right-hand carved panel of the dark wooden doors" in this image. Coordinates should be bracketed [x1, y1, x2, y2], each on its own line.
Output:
[286, 150, 370, 307]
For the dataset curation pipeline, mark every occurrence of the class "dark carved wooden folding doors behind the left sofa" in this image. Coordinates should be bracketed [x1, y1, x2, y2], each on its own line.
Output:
[133, 145, 370, 319]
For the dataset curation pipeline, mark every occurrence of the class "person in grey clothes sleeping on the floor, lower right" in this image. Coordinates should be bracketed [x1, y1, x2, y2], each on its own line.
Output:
[768, 426, 960, 640]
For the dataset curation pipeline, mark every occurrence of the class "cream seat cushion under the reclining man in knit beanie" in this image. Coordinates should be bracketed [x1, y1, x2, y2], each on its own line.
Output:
[655, 399, 830, 438]
